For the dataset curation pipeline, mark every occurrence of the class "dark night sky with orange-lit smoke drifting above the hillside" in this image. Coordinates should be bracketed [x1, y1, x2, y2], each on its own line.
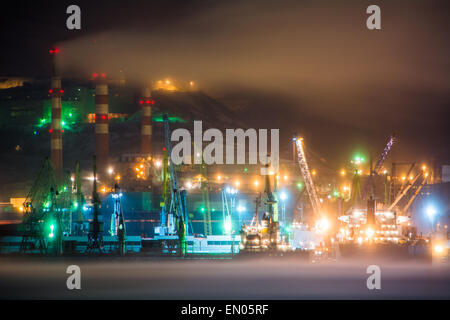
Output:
[0, 0, 450, 168]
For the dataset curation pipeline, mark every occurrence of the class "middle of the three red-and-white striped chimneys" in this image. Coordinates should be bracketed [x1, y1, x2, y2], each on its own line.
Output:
[94, 73, 109, 173]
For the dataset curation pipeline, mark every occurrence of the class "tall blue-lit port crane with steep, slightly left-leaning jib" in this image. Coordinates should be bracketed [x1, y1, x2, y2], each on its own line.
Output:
[163, 114, 188, 256]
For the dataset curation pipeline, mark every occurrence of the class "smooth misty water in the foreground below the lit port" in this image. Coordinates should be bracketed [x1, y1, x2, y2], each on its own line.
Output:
[0, 257, 450, 299]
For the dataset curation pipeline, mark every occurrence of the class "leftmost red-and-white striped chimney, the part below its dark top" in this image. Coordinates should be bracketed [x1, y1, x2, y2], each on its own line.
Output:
[50, 77, 63, 180]
